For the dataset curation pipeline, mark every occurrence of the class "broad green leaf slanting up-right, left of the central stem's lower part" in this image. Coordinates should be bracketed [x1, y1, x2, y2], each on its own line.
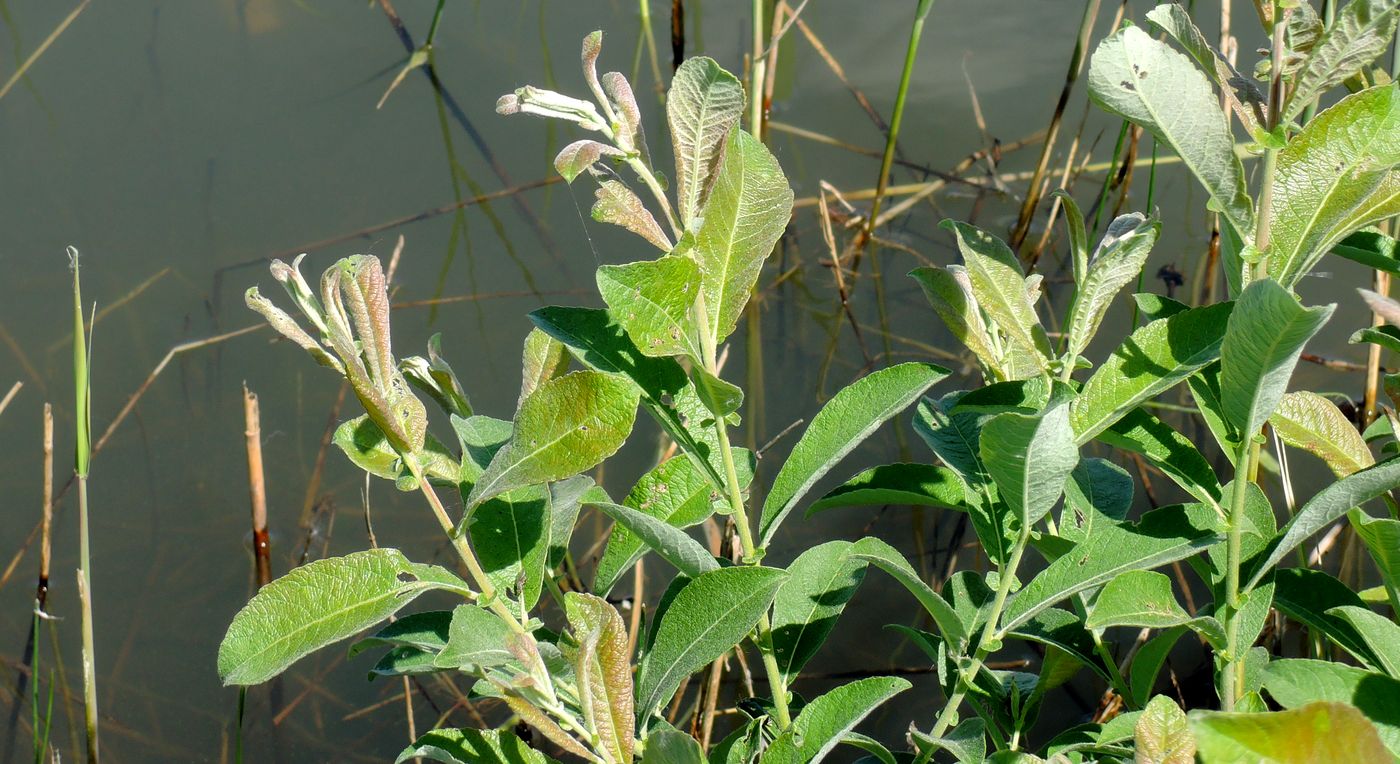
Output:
[637, 567, 787, 719]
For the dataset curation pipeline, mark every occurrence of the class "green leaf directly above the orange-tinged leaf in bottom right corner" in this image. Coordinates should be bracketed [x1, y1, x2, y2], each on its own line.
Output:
[1264, 659, 1400, 761]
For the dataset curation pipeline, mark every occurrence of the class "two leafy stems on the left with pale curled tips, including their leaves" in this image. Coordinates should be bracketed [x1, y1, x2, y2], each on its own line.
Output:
[218, 34, 948, 764]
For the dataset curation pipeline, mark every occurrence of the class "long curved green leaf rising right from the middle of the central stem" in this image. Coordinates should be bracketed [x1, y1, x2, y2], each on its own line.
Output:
[759, 362, 949, 547]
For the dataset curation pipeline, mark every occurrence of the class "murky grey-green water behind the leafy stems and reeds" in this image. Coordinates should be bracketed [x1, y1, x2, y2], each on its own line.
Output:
[0, 0, 1365, 761]
